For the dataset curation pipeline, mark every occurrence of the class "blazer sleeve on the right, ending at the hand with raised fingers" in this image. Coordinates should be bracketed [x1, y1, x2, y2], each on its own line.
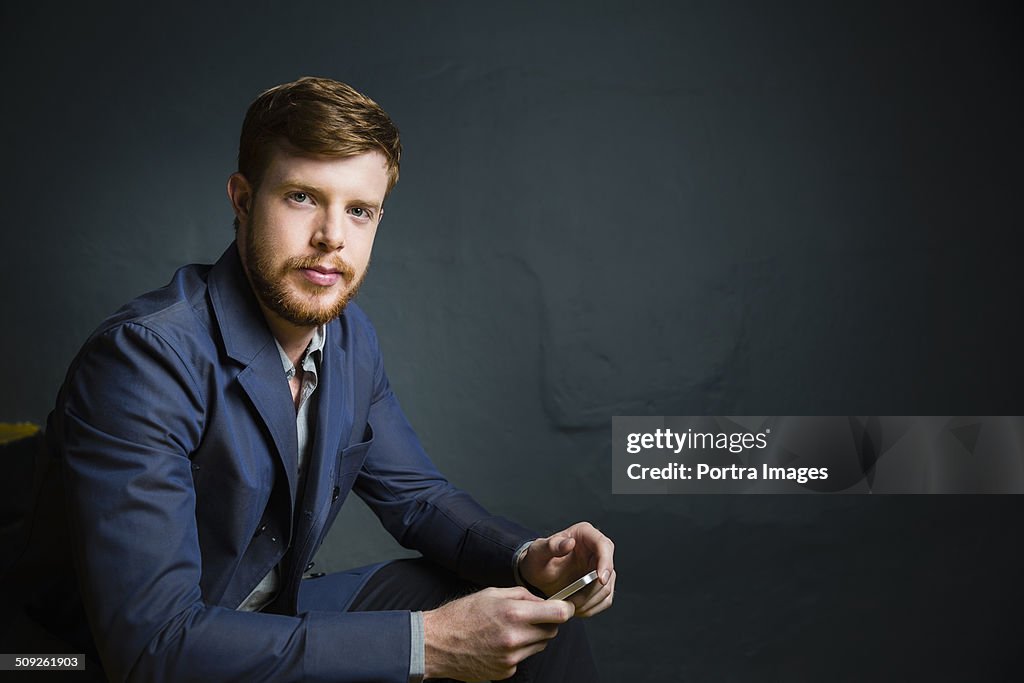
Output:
[353, 322, 539, 586]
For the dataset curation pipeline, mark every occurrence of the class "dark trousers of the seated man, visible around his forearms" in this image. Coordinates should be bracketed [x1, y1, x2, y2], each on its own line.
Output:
[300, 558, 599, 683]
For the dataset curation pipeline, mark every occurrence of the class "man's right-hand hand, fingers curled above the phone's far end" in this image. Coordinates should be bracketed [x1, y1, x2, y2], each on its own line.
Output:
[519, 522, 615, 616]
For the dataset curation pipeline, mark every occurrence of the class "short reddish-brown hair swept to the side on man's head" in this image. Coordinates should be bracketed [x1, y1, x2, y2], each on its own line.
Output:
[239, 76, 401, 193]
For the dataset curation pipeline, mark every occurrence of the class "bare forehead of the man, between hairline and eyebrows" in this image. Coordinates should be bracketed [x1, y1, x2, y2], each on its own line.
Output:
[260, 144, 388, 202]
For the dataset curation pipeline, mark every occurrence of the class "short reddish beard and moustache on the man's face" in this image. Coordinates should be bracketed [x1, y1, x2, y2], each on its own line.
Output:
[246, 223, 369, 327]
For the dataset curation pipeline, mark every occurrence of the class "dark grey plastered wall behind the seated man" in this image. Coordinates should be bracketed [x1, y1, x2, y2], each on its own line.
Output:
[0, 2, 1024, 681]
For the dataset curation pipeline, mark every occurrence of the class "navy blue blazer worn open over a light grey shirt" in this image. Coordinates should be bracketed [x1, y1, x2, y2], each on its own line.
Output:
[30, 245, 536, 683]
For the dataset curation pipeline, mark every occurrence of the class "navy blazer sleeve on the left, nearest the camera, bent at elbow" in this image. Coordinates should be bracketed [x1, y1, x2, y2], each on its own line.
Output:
[53, 324, 410, 683]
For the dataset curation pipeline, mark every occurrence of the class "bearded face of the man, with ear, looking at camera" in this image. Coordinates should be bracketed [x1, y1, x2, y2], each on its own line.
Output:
[228, 145, 388, 328]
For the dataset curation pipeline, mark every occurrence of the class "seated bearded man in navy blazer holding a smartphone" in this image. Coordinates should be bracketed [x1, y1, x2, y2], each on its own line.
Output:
[6, 78, 615, 682]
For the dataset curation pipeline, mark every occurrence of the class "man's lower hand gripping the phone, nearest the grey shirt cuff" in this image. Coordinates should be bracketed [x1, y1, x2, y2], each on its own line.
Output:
[423, 588, 573, 681]
